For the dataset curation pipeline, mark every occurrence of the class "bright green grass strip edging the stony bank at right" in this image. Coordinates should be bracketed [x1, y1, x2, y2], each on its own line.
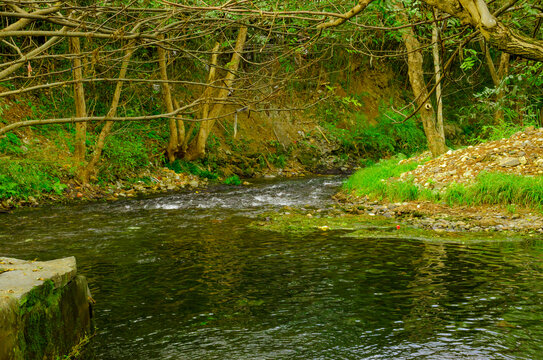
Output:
[344, 158, 543, 212]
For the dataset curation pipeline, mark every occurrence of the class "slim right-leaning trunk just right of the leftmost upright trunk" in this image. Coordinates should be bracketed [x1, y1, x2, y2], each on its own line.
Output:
[81, 42, 134, 183]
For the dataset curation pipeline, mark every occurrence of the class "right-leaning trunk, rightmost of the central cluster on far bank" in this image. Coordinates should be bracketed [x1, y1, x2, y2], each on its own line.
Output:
[185, 26, 247, 160]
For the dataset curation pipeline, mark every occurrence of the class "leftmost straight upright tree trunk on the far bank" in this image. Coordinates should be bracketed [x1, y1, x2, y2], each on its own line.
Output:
[70, 37, 87, 161]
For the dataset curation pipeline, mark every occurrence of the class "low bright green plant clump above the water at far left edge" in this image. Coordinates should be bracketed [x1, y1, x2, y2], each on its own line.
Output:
[0, 161, 66, 199]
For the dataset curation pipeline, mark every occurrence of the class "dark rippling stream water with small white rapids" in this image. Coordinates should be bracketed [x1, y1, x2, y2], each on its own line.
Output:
[0, 178, 543, 360]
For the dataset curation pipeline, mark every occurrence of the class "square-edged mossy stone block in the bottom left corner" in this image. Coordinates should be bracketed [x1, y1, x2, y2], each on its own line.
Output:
[0, 257, 93, 359]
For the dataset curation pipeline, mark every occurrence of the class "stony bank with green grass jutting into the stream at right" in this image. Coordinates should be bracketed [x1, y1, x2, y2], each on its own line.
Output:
[335, 127, 543, 233]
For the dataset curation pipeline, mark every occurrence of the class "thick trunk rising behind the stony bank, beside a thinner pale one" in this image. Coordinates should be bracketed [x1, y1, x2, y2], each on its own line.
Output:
[395, 1, 447, 157]
